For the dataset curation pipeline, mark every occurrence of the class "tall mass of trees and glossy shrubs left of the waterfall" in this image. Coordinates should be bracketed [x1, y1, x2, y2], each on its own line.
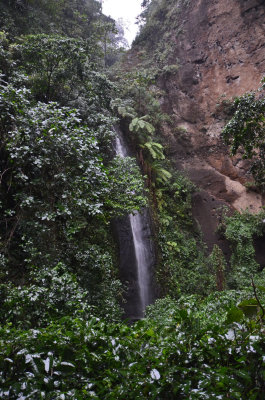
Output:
[0, 1, 146, 329]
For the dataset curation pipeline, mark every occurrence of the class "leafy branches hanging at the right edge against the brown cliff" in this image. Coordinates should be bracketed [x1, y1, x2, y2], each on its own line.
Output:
[222, 80, 265, 190]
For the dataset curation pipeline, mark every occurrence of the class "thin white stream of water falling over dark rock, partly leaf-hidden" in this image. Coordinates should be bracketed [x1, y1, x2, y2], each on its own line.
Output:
[116, 136, 152, 317]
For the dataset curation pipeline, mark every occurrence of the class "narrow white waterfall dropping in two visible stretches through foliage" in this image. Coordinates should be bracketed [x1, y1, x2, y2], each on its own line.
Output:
[113, 132, 154, 318]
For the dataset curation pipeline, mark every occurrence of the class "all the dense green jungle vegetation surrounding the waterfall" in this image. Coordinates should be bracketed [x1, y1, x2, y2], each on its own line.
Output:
[0, 0, 265, 400]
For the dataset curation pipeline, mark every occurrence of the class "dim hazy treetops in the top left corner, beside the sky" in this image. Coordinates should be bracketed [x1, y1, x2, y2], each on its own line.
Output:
[0, 0, 127, 71]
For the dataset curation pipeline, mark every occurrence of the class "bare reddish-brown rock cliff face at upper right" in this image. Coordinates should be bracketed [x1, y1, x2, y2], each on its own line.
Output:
[156, 0, 265, 248]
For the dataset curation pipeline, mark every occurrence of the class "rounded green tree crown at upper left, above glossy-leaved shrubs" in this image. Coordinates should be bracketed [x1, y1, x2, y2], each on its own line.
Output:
[11, 34, 96, 102]
